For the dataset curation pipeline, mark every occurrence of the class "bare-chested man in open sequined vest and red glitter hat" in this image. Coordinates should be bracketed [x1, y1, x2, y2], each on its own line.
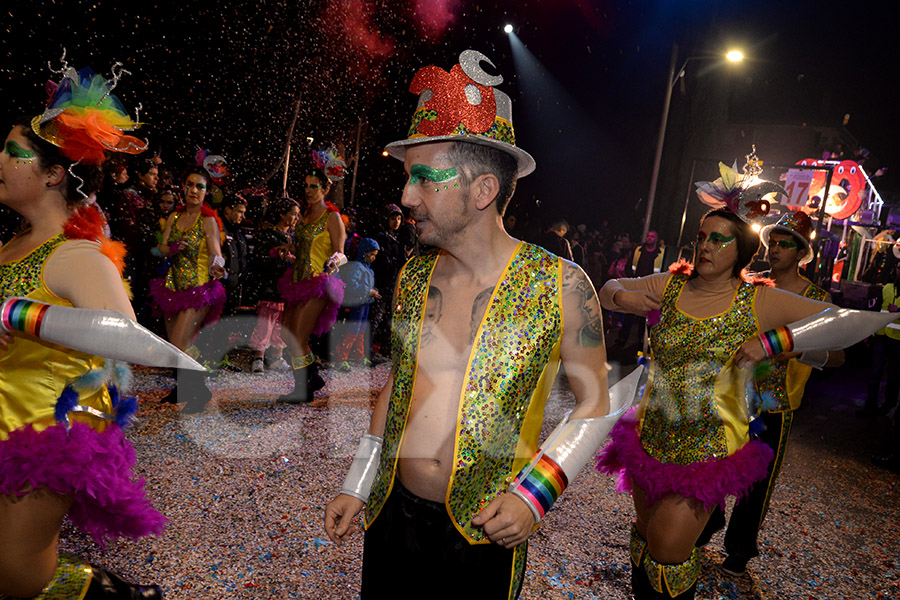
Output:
[325, 50, 621, 598]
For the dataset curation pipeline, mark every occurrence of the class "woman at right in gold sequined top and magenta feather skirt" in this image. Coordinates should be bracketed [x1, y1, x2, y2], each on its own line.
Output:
[597, 155, 900, 600]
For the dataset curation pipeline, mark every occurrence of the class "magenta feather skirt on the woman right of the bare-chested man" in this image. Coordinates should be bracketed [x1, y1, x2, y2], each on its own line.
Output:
[597, 407, 775, 510]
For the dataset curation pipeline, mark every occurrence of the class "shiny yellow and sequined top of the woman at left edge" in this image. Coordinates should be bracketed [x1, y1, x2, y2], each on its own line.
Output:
[0, 234, 113, 440]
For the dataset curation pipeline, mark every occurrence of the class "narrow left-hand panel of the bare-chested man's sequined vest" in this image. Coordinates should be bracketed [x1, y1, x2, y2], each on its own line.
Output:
[365, 254, 437, 527]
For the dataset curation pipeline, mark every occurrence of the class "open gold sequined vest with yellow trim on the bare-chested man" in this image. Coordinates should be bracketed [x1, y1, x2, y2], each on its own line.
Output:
[365, 243, 563, 544]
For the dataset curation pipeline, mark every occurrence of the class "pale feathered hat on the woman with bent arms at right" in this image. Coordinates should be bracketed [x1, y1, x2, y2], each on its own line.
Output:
[694, 146, 787, 222]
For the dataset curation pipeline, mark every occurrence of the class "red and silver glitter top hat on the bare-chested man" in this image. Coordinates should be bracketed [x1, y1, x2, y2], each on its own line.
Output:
[385, 50, 535, 177]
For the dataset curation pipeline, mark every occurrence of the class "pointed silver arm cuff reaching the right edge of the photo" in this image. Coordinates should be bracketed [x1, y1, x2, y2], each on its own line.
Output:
[787, 307, 897, 352]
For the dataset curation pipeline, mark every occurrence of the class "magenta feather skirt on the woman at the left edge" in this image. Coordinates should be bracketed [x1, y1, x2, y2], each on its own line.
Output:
[0, 421, 167, 546]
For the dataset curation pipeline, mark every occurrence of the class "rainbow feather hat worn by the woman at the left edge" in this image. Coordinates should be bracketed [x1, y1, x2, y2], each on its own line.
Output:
[31, 52, 147, 165]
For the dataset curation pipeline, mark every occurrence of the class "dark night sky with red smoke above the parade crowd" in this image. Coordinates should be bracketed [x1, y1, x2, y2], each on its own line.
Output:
[0, 0, 900, 239]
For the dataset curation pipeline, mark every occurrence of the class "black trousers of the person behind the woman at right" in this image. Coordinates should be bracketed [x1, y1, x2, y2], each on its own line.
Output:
[698, 411, 794, 560]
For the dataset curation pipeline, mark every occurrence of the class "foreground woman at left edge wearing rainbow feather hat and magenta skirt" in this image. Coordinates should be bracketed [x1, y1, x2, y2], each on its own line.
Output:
[0, 58, 166, 599]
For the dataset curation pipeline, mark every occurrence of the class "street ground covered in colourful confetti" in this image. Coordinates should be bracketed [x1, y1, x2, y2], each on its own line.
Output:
[60, 364, 900, 600]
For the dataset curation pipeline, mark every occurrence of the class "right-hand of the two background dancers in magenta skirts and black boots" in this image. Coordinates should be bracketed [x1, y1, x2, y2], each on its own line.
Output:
[278, 168, 347, 404]
